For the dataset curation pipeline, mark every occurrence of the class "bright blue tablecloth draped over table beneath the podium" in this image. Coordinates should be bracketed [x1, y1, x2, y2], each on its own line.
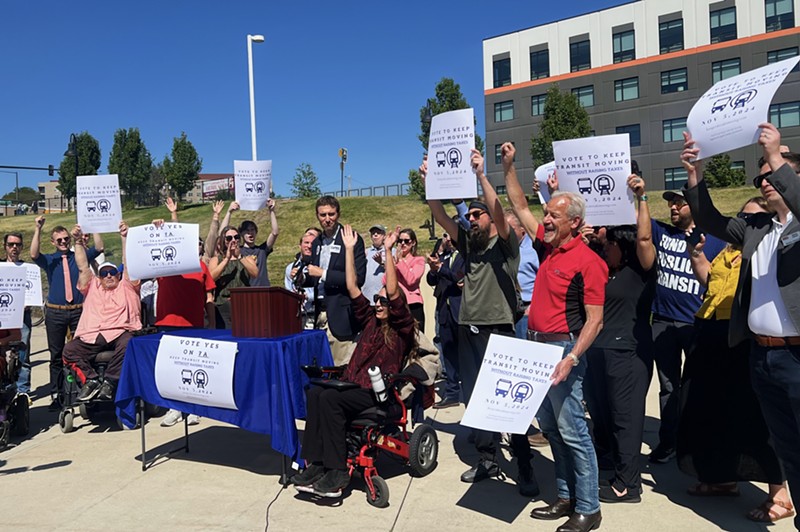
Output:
[116, 329, 333, 460]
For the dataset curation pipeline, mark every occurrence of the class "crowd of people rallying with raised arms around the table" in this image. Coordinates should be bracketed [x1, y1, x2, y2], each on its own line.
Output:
[4, 123, 800, 532]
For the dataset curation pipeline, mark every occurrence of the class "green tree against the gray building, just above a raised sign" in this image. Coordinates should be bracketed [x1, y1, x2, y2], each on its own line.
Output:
[531, 83, 592, 168]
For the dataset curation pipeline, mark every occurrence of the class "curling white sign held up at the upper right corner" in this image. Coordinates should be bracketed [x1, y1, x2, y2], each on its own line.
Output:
[686, 57, 800, 159]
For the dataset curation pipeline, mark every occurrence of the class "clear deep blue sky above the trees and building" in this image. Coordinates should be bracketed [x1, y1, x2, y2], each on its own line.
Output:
[0, 0, 624, 200]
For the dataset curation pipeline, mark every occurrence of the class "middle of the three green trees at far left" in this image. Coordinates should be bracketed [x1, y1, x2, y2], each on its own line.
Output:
[108, 127, 153, 205]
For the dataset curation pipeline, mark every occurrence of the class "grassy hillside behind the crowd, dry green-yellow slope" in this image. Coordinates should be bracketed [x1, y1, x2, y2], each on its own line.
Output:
[0, 187, 758, 286]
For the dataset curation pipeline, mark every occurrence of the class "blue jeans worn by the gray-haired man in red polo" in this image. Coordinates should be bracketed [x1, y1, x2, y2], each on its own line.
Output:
[536, 341, 600, 515]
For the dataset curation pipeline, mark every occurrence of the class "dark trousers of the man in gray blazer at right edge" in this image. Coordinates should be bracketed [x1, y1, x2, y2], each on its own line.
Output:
[750, 343, 800, 530]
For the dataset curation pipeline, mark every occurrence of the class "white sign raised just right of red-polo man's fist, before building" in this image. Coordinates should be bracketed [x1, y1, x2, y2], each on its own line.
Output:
[553, 133, 636, 226]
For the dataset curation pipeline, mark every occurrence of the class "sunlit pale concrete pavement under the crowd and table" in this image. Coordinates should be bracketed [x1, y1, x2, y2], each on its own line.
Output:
[0, 326, 793, 532]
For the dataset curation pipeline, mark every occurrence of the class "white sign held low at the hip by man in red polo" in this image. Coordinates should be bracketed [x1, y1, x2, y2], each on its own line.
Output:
[461, 334, 564, 434]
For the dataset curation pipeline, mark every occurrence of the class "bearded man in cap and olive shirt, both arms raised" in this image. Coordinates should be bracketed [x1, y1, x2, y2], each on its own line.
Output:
[419, 150, 539, 497]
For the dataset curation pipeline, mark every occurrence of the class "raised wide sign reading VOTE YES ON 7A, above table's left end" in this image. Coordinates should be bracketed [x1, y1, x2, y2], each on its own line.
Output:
[125, 222, 200, 279]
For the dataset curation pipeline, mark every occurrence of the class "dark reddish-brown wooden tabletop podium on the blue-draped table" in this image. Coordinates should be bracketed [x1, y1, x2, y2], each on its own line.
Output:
[231, 286, 303, 338]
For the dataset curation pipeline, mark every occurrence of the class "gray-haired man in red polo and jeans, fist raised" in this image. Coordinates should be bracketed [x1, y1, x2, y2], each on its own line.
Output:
[502, 142, 608, 532]
